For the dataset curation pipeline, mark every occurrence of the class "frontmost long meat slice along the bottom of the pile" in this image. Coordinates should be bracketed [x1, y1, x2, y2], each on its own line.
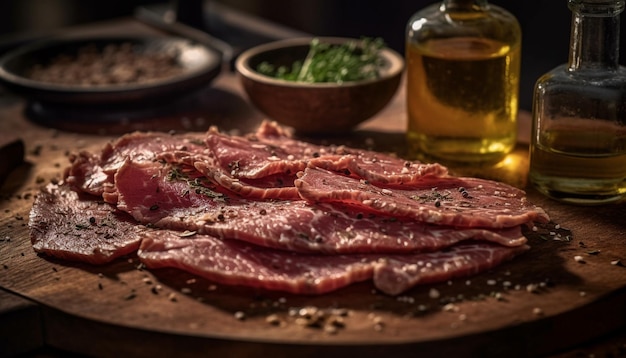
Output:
[138, 230, 528, 295]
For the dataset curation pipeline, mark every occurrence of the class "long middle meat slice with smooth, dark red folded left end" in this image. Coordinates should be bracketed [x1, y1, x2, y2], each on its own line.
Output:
[116, 161, 526, 254]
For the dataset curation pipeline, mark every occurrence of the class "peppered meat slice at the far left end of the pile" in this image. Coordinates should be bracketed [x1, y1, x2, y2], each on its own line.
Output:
[28, 184, 142, 264]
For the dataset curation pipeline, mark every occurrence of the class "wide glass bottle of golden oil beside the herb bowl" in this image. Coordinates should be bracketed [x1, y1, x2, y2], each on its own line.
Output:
[406, 0, 522, 164]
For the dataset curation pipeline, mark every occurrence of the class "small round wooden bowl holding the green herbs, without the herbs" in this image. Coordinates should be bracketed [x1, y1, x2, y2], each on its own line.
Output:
[235, 37, 404, 135]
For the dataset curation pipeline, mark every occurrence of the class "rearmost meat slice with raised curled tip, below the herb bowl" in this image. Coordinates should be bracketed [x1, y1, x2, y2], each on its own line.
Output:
[206, 121, 447, 183]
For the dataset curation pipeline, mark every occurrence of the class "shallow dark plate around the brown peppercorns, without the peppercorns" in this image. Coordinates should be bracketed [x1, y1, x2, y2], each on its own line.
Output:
[0, 36, 222, 105]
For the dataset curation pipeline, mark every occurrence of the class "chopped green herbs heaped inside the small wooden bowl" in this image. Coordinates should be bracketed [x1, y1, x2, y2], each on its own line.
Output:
[257, 38, 385, 83]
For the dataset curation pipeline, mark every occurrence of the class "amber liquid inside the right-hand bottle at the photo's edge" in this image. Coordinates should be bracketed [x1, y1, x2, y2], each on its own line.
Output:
[529, 102, 626, 205]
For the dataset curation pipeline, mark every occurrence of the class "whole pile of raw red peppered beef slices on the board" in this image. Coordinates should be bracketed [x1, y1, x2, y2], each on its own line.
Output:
[29, 122, 549, 295]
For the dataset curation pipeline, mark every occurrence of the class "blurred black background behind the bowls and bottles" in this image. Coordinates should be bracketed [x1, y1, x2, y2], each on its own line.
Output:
[0, 0, 626, 109]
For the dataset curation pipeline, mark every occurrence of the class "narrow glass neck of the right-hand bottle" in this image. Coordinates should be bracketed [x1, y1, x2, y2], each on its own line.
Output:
[569, 0, 624, 70]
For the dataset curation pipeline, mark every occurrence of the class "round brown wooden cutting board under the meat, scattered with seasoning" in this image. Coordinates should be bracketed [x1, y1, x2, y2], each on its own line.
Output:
[0, 75, 626, 357]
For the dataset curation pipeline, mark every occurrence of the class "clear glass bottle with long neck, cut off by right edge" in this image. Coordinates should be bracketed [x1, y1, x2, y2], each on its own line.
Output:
[529, 0, 626, 205]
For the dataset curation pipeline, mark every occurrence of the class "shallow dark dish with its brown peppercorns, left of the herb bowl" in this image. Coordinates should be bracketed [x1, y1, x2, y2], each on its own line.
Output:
[0, 36, 222, 105]
